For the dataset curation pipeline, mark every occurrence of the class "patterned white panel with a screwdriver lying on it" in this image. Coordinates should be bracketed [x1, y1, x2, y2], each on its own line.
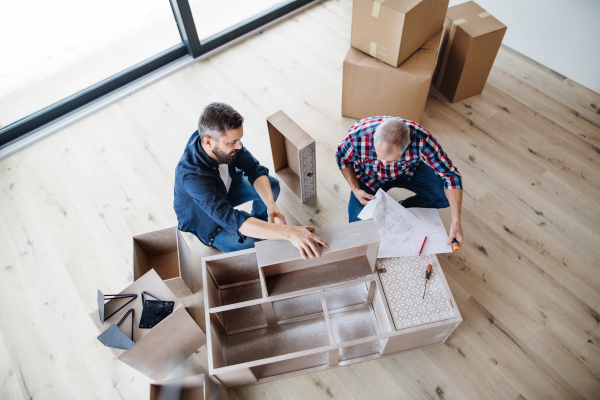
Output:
[377, 255, 456, 330]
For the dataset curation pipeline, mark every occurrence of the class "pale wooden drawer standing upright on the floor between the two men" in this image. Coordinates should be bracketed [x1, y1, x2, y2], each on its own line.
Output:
[267, 111, 317, 203]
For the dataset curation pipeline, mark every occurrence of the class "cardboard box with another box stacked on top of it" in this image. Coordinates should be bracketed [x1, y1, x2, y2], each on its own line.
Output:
[342, 31, 442, 122]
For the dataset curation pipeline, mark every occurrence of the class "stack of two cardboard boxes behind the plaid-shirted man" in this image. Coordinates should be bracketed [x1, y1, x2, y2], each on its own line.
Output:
[342, 0, 449, 122]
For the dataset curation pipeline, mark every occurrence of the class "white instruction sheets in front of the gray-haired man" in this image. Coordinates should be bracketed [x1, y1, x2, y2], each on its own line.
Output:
[358, 189, 452, 258]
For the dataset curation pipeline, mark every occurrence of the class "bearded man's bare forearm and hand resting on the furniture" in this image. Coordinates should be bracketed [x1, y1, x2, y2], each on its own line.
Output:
[240, 217, 329, 259]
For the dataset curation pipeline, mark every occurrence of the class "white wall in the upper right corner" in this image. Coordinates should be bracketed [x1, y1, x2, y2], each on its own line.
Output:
[450, 0, 600, 93]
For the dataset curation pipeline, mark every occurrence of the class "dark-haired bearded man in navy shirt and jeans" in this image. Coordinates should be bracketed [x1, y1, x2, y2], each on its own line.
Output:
[173, 103, 329, 258]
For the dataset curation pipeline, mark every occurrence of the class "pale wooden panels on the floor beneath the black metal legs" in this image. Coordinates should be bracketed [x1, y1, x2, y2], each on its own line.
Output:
[90, 270, 206, 380]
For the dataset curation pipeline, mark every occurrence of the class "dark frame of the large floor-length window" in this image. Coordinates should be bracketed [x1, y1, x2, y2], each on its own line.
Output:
[0, 0, 316, 148]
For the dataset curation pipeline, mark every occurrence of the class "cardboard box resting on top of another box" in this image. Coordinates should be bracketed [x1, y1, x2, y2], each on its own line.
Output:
[350, 0, 449, 67]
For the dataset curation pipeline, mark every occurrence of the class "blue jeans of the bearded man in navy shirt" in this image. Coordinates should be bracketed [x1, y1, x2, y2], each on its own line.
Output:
[213, 172, 280, 253]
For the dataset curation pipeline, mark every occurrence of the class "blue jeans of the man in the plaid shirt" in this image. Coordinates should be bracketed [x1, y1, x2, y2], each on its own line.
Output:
[348, 162, 450, 222]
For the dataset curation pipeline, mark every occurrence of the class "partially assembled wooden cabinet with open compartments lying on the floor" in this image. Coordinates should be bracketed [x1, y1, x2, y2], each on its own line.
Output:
[202, 220, 462, 389]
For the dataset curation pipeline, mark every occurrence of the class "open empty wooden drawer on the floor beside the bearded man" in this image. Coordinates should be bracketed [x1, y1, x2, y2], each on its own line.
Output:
[133, 227, 194, 298]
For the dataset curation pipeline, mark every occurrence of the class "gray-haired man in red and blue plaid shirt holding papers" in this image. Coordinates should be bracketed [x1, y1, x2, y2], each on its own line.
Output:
[336, 117, 463, 245]
